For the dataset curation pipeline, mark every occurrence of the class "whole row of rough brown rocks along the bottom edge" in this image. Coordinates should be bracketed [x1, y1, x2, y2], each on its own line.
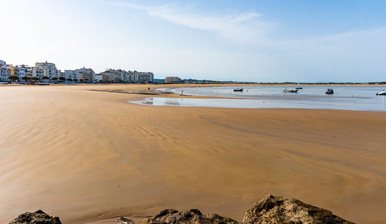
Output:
[9, 195, 353, 224]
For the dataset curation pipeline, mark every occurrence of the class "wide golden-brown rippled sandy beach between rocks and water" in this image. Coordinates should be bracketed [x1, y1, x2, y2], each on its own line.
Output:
[0, 85, 386, 223]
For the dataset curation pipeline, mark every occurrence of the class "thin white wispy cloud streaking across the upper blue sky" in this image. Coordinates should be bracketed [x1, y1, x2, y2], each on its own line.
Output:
[114, 3, 274, 44]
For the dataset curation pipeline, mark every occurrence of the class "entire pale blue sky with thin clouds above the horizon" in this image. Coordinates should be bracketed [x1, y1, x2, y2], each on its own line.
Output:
[0, 0, 386, 82]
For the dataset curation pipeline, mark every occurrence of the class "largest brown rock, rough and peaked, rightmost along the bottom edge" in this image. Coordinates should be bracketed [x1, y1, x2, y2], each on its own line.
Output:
[243, 195, 352, 224]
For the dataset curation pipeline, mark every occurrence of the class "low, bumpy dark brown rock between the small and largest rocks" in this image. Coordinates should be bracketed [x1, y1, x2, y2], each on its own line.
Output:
[138, 209, 237, 224]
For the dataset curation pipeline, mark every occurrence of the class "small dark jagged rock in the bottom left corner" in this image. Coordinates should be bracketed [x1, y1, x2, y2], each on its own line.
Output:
[9, 210, 62, 224]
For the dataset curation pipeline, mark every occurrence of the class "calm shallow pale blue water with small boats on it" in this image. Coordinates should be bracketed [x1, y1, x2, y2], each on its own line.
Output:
[131, 86, 386, 112]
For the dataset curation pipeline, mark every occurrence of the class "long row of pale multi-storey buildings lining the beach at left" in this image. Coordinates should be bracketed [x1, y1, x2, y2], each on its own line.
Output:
[0, 60, 154, 83]
